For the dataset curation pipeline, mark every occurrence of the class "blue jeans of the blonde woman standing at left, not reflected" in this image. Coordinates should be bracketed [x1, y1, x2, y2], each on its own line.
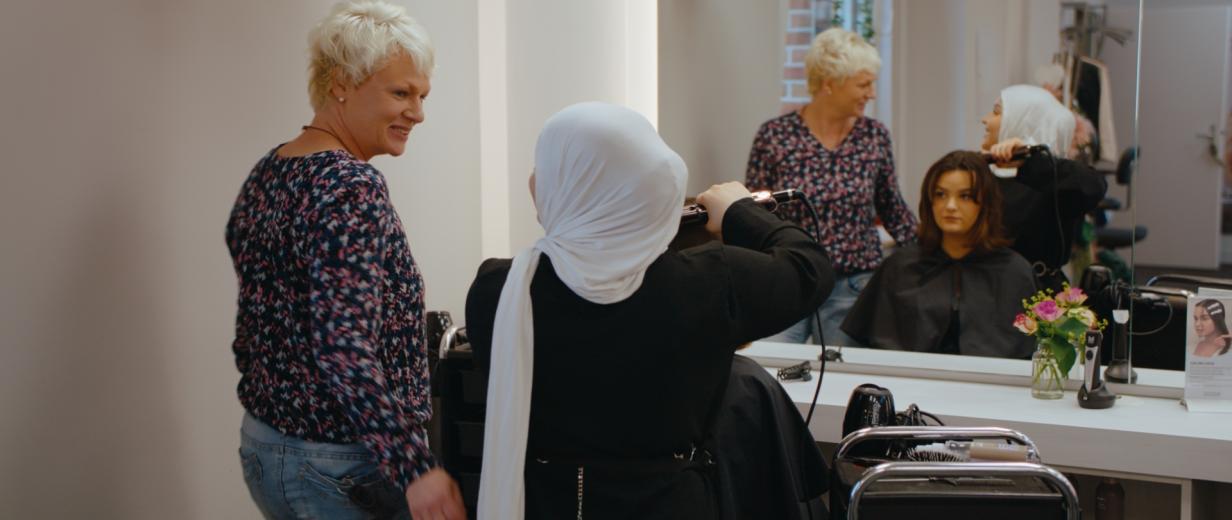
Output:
[239, 413, 410, 520]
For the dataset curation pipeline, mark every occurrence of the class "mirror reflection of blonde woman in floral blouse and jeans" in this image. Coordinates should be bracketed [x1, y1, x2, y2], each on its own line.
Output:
[745, 28, 915, 345]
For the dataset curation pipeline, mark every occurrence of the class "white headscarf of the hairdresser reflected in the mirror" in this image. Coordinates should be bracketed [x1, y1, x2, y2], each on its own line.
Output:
[997, 85, 1074, 159]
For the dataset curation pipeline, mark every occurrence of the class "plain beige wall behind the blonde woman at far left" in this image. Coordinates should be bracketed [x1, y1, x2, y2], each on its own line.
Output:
[0, 0, 479, 519]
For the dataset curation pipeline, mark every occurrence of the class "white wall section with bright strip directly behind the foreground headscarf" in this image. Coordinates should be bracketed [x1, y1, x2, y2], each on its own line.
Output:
[506, 0, 657, 254]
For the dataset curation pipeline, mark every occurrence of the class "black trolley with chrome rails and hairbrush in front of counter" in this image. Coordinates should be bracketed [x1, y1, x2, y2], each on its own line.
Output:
[830, 426, 1080, 520]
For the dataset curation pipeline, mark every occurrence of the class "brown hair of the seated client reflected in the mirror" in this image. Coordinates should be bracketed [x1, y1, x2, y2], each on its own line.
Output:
[919, 150, 1010, 253]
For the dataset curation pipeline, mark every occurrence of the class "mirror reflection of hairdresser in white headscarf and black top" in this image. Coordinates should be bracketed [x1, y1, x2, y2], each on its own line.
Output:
[981, 85, 1108, 291]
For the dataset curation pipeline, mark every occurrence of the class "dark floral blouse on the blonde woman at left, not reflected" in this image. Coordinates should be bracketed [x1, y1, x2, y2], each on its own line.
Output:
[227, 148, 436, 488]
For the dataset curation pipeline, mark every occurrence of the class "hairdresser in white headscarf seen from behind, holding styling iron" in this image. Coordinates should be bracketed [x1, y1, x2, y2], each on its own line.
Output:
[467, 102, 834, 519]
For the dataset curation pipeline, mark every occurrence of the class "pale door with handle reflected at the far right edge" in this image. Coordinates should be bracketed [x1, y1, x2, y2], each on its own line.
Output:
[1133, 2, 1232, 270]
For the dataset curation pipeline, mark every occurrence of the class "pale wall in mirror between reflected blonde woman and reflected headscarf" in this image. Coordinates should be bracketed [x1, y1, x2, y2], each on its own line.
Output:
[891, 0, 1061, 208]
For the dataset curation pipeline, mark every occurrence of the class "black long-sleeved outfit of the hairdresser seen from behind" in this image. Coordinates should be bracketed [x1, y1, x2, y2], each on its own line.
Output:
[466, 200, 834, 520]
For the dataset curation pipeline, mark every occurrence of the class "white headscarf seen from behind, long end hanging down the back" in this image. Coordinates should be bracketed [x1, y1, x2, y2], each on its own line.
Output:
[478, 102, 689, 520]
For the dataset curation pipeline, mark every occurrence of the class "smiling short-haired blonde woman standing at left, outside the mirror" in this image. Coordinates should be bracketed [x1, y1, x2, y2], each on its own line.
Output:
[227, 1, 466, 520]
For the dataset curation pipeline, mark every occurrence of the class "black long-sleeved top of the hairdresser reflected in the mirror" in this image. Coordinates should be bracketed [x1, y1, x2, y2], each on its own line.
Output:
[998, 154, 1108, 276]
